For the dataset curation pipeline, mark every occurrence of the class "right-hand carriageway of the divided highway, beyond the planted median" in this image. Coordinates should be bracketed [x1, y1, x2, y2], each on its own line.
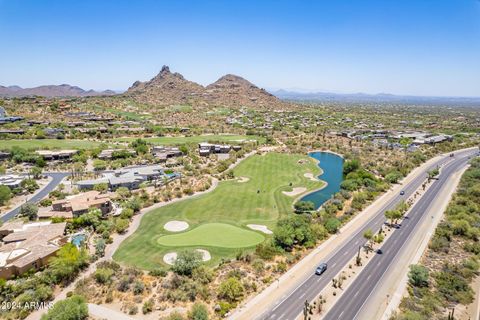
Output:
[324, 152, 474, 320]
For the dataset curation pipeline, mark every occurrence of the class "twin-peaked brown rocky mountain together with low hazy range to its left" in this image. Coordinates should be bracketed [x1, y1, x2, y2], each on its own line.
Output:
[0, 66, 288, 109]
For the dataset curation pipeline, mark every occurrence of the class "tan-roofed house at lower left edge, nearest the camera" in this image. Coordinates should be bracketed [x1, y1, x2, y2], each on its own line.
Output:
[0, 222, 67, 279]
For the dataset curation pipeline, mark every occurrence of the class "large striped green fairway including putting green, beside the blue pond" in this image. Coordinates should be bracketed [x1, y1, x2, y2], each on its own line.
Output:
[114, 153, 323, 269]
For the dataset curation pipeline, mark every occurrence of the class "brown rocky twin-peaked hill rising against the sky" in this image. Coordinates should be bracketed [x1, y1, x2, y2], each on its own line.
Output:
[125, 66, 289, 110]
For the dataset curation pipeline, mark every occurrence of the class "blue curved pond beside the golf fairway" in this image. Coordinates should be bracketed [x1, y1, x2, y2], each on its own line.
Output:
[300, 152, 343, 209]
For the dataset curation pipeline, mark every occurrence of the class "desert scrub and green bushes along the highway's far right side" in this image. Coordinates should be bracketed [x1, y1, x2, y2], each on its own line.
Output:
[396, 159, 480, 320]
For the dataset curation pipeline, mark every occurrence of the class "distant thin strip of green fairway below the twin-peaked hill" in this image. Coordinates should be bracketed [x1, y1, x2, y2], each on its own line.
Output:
[115, 135, 265, 145]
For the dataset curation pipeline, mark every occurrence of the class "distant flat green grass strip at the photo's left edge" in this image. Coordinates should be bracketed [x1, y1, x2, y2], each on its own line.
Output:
[0, 139, 101, 150]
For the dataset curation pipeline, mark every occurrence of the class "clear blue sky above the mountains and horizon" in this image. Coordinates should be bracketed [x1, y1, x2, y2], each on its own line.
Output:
[0, 0, 480, 96]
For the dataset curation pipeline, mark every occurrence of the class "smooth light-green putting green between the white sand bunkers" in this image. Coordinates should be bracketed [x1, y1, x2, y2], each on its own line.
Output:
[158, 223, 265, 248]
